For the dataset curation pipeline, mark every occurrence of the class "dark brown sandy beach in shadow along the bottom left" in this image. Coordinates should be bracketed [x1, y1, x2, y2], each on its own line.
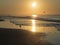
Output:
[0, 28, 53, 45]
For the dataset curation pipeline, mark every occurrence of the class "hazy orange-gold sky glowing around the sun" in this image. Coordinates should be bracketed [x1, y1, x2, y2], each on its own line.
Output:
[0, 0, 60, 15]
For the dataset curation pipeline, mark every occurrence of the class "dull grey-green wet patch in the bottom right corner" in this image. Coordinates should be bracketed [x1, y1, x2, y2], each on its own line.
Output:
[46, 30, 60, 45]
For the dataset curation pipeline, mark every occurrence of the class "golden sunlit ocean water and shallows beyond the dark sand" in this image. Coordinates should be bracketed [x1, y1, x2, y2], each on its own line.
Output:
[0, 15, 60, 45]
